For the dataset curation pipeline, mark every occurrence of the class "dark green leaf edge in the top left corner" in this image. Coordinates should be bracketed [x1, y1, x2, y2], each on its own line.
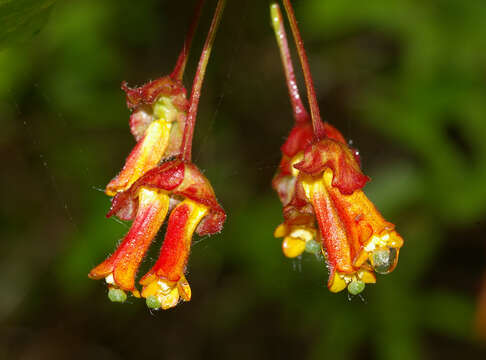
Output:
[0, 0, 56, 49]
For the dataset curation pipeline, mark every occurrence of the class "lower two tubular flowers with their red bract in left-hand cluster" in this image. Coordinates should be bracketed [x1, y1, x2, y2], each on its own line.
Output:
[90, 160, 226, 309]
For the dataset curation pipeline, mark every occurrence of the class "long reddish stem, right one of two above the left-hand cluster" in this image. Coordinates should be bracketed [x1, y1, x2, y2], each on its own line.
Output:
[181, 0, 226, 161]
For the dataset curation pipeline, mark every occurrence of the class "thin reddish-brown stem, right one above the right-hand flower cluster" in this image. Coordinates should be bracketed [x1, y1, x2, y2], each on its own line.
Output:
[283, 0, 324, 138]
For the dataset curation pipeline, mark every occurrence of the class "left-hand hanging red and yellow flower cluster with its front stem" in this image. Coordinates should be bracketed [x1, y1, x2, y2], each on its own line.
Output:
[89, 0, 226, 309]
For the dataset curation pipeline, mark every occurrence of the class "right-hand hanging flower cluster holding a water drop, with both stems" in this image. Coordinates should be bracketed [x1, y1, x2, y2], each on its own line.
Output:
[271, 0, 403, 295]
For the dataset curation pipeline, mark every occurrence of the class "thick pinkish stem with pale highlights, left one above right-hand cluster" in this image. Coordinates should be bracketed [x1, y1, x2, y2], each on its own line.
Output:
[270, 3, 309, 122]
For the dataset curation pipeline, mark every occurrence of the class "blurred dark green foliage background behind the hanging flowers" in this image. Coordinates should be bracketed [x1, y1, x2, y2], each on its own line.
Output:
[0, 0, 486, 360]
